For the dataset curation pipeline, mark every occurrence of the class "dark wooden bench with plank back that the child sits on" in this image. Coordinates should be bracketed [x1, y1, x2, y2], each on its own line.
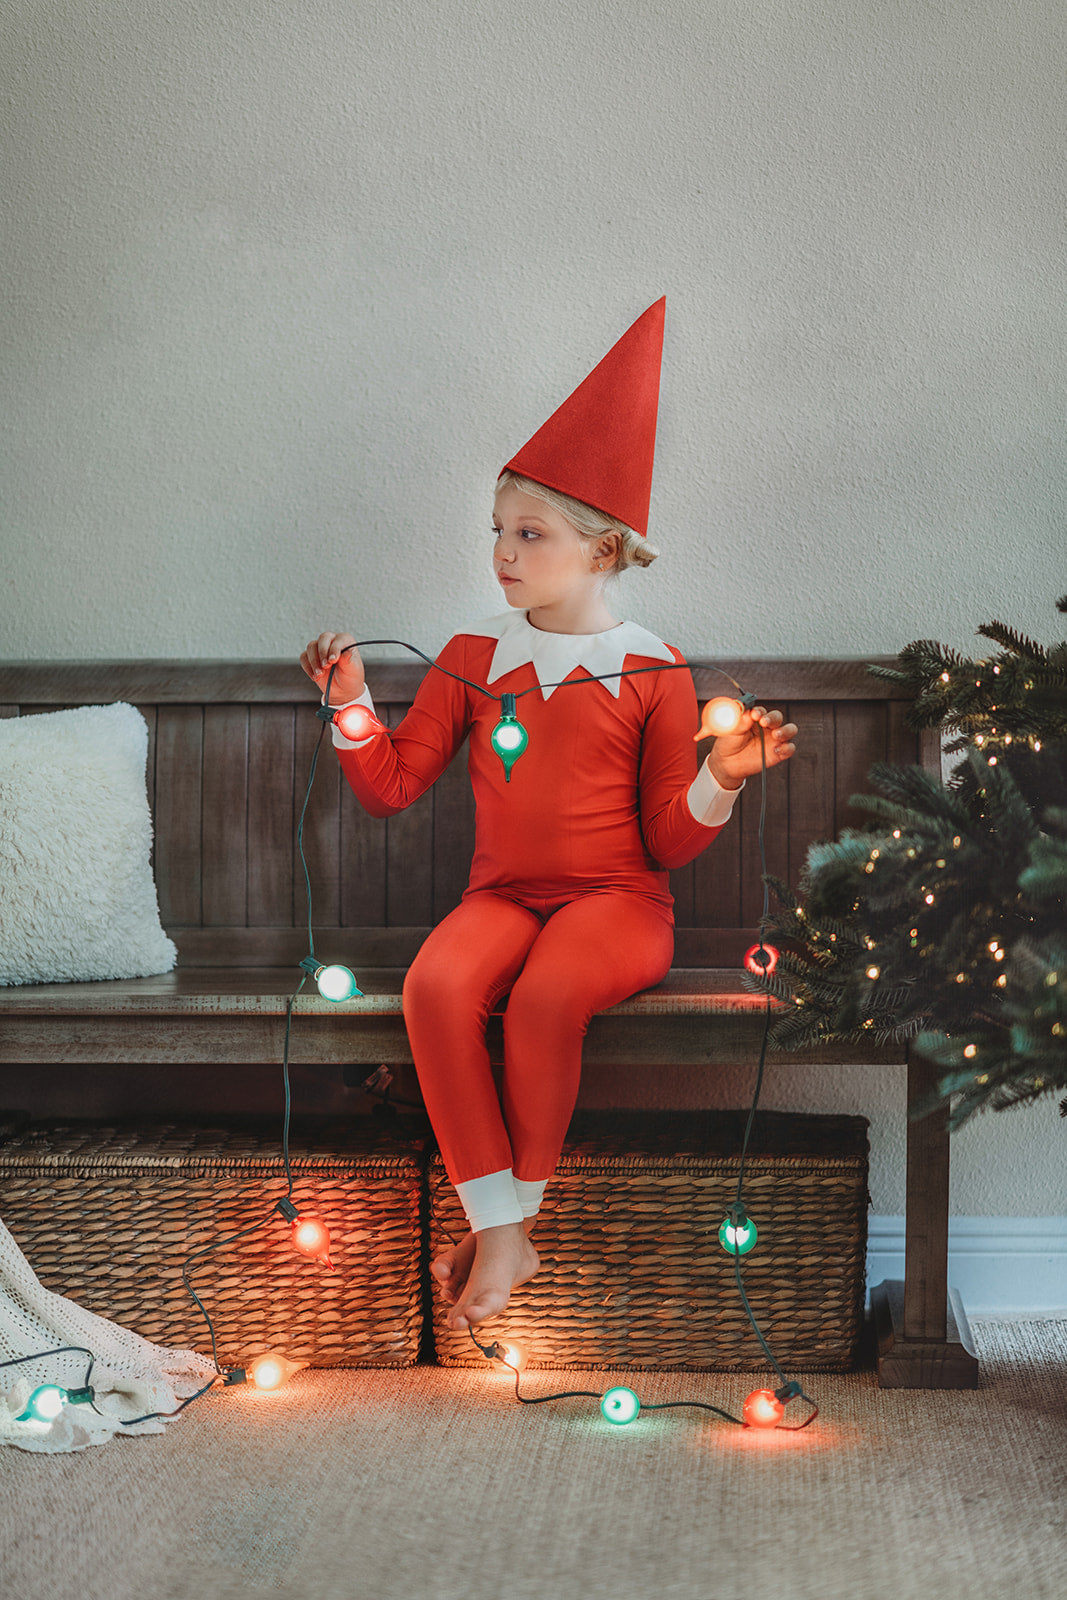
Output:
[0, 659, 977, 1387]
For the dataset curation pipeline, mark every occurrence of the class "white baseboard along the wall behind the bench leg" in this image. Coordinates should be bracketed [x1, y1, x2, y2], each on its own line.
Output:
[867, 1216, 1067, 1317]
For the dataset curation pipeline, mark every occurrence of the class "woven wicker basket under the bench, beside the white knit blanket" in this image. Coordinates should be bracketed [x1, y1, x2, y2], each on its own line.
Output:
[0, 1122, 422, 1366]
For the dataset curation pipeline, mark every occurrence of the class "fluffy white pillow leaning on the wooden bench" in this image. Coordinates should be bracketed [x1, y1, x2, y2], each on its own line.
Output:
[0, 702, 178, 984]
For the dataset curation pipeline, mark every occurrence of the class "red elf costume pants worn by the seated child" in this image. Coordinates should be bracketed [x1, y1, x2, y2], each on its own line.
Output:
[403, 890, 673, 1184]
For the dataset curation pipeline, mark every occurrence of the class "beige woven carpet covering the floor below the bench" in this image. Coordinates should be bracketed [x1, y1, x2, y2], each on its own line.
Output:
[0, 1322, 1067, 1600]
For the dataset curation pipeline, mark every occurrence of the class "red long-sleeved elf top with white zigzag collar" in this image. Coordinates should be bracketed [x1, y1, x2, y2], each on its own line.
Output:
[334, 616, 729, 909]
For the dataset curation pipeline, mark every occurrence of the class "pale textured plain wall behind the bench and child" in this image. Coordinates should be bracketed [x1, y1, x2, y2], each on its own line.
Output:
[0, 0, 1067, 1214]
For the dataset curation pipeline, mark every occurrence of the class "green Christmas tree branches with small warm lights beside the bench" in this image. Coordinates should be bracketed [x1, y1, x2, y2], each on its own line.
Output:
[745, 597, 1067, 1126]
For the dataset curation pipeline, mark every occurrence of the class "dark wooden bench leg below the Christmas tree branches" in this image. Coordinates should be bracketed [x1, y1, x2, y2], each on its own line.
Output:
[870, 1050, 979, 1389]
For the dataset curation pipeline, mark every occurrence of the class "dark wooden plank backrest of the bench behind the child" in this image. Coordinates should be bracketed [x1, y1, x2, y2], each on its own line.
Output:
[0, 658, 939, 966]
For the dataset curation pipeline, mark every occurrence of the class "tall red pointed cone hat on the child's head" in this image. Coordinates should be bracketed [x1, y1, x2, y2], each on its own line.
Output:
[504, 298, 667, 536]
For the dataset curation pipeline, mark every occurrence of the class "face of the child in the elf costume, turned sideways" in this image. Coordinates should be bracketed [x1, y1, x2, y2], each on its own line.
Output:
[493, 483, 591, 611]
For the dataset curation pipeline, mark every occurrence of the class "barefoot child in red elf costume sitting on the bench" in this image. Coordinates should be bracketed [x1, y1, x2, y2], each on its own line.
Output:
[301, 301, 797, 1328]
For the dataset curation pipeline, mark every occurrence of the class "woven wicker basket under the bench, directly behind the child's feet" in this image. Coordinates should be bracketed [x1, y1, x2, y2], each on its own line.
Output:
[429, 1112, 867, 1371]
